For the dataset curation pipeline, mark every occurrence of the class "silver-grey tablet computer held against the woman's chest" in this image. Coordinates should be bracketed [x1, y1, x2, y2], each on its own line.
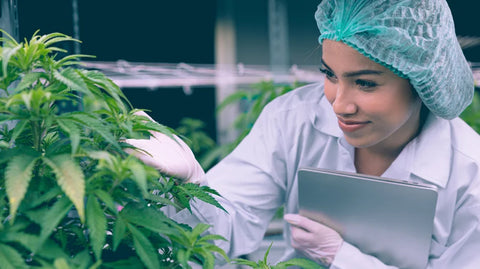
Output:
[298, 168, 437, 268]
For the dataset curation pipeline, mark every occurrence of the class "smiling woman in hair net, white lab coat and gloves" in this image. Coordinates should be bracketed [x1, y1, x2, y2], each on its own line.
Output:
[126, 0, 480, 268]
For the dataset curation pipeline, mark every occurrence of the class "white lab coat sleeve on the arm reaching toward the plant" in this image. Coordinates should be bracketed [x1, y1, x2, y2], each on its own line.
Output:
[172, 102, 286, 257]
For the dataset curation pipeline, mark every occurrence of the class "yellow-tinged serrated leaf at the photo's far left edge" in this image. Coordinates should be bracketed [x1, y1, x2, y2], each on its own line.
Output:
[5, 154, 38, 219]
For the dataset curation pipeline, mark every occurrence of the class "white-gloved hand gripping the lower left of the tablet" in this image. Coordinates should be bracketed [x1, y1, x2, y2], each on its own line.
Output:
[283, 214, 343, 267]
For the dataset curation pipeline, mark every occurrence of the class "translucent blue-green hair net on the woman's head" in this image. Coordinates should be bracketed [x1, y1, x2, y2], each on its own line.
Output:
[315, 0, 474, 119]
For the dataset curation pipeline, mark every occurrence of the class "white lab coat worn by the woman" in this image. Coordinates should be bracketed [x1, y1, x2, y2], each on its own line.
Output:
[175, 83, 480, 269]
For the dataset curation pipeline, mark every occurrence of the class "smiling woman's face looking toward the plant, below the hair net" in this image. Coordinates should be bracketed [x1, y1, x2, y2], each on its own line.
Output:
[321, 40, 421, 152]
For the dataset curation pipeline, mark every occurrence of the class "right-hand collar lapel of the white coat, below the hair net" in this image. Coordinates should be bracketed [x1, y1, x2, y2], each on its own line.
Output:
[407, 113, 452, 188]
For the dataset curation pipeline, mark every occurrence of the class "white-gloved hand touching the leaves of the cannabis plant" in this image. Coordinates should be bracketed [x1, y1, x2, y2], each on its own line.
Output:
[125, 111, 205, 183]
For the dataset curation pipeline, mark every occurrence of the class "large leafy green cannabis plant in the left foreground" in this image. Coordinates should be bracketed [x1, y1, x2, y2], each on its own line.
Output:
[0, 30, 226, 268]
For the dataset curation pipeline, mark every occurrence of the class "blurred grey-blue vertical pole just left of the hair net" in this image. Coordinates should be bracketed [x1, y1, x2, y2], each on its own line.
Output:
[268, 0, 290, 80]
